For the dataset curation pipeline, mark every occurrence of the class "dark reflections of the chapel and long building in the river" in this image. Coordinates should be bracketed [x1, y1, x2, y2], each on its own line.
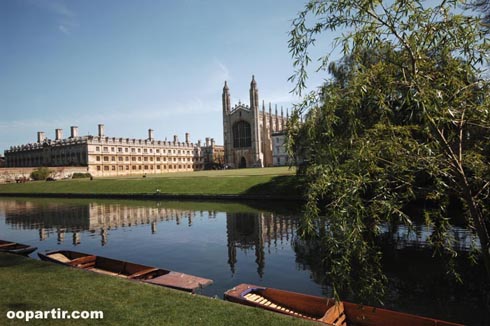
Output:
[0, 201, 297, 277]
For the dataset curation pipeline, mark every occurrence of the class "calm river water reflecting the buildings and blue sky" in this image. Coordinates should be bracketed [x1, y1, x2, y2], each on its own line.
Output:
[0, 199, 490, 325]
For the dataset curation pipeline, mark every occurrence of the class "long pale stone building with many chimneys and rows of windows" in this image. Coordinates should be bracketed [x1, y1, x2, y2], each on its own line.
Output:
[5, 124, 219, 176]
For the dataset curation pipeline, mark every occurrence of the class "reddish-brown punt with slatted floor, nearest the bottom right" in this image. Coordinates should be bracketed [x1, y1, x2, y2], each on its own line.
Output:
[224, 284, 462, 326]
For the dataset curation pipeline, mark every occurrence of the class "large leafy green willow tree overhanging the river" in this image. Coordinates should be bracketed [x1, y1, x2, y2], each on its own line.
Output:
[289, 0, 490, 296]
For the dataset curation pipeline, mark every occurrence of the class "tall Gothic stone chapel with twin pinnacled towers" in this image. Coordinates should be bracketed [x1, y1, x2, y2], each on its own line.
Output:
[222, 76, 288, 168]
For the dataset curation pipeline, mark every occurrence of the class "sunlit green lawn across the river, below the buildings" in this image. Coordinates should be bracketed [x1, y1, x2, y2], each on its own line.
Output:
[0, 167, 300, 198]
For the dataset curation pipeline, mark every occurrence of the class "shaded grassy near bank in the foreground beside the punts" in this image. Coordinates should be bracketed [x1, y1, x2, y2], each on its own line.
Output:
[0, 253, 311, 325]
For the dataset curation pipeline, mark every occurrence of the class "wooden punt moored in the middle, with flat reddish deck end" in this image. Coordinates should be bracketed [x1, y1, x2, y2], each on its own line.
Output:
[38, 250, 213, 293]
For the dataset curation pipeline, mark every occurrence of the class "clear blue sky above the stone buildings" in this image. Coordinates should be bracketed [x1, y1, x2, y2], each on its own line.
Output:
[0, 0, 334, 153]
